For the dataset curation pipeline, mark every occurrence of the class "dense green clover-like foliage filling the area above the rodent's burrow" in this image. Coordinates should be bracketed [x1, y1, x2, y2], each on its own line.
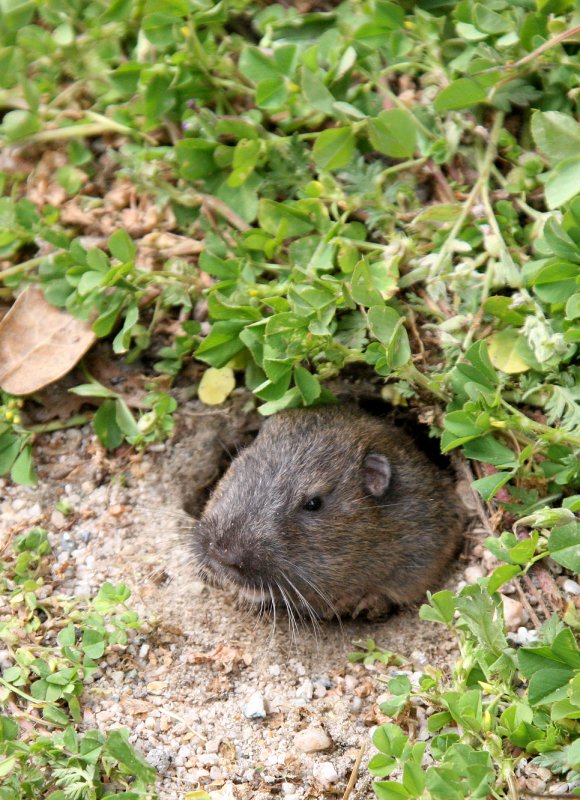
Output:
[0, 0, 580, 499]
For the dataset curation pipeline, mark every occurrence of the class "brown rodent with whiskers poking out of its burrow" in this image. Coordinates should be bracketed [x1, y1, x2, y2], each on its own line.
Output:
[190, 406, 464, 618]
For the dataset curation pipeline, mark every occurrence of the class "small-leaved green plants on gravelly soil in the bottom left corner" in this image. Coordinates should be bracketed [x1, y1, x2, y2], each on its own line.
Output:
[0, 528, 155, 800]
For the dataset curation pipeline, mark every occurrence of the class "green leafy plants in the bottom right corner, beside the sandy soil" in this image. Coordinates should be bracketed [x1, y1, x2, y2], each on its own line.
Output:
[369, 508, 580, 800]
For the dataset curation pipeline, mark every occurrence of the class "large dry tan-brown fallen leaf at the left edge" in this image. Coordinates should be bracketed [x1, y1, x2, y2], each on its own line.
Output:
[0, 286, 97, 395]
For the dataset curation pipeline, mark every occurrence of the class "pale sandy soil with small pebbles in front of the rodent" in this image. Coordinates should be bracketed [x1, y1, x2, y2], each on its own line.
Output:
[0, 394, 484, 800]
